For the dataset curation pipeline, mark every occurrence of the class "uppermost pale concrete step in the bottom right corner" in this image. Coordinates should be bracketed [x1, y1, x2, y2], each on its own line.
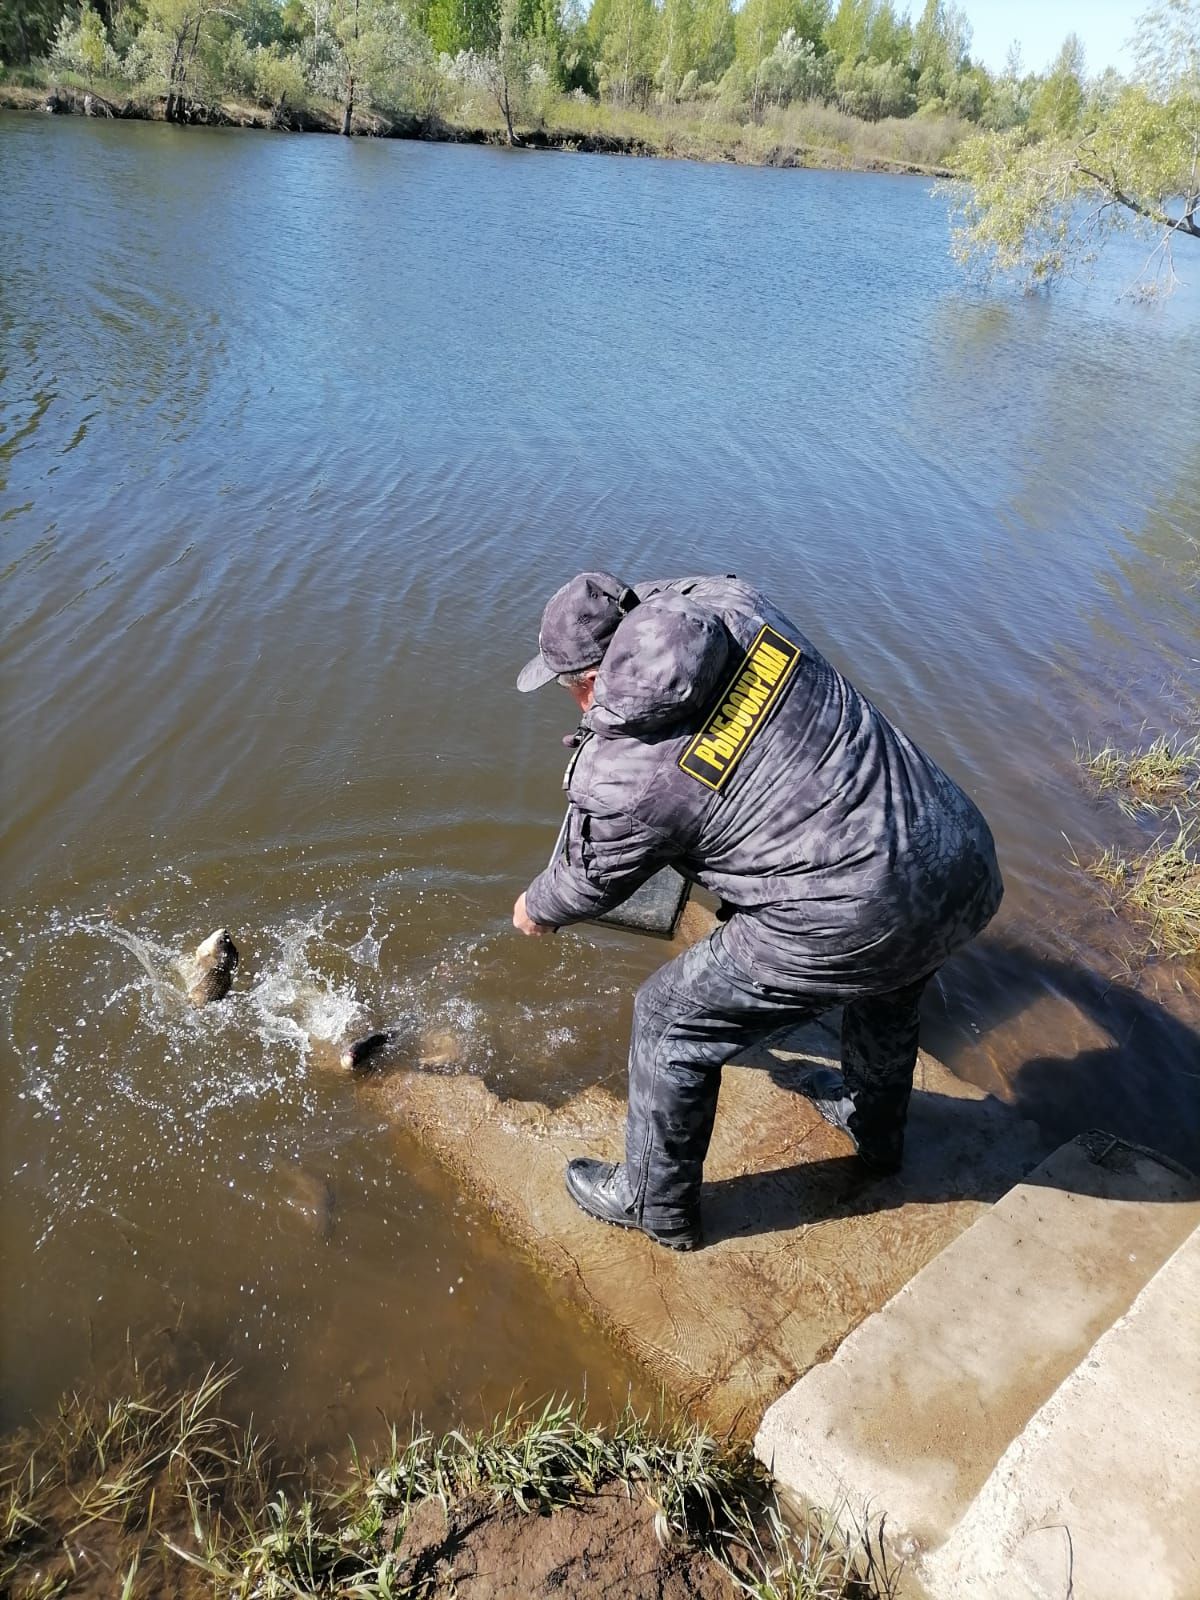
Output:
[925, 1229, 1200, 1600]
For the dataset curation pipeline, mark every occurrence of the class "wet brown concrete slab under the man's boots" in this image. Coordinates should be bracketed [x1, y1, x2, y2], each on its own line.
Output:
[373, 1024, 1045, 1434]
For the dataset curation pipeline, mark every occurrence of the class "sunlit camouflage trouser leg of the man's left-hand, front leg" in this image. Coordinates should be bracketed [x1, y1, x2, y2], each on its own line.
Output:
[626, 928, 834, 1227]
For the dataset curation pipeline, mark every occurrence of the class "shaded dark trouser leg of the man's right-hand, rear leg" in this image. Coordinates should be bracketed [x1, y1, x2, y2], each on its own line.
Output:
[842, 974, 933, 1162]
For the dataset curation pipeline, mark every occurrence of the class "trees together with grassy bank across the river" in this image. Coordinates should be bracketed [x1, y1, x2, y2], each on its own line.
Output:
[0, 0, 1158, 171]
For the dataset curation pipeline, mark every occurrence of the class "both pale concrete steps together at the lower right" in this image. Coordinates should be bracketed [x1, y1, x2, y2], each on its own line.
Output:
[755, 1134, 1200, 1600]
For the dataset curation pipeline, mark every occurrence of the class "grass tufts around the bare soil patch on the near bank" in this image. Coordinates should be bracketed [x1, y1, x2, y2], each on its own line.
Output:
[0, 1371, 894, 1600]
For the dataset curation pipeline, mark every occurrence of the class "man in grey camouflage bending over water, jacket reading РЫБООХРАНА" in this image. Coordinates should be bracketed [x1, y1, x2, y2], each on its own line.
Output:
[512, 573, 1003, 1250]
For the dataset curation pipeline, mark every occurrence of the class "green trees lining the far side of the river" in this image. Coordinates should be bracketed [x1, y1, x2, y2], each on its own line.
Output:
[0, 0, 1110, 142]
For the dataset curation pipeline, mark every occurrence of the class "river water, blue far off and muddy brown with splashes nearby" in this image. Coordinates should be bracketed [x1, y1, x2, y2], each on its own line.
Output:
[0, 115, 1200, 1442]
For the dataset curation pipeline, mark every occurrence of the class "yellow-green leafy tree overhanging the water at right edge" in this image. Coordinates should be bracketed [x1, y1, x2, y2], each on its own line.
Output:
[952, 0, 1200, 290]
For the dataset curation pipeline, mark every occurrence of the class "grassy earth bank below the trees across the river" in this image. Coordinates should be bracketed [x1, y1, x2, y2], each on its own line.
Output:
[0, 80, 954, 178]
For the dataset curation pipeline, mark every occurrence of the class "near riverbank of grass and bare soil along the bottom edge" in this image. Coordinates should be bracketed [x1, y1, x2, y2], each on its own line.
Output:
[0, 1366, 894, 1600]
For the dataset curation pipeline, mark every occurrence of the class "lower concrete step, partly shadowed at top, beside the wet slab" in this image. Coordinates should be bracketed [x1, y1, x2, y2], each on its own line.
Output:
[755, 1134, 1200, 1600]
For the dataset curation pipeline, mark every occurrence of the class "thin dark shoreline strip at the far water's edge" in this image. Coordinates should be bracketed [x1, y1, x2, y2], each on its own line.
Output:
[0, 83, 954, 178]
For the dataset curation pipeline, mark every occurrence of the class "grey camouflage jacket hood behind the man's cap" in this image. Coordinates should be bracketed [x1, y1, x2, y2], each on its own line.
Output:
[586, 594, 733, 734]
